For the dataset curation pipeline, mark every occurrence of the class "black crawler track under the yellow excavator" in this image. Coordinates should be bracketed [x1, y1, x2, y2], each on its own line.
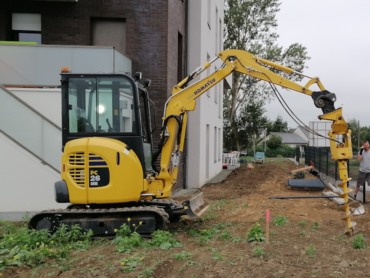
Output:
[28, 199, 179, 237]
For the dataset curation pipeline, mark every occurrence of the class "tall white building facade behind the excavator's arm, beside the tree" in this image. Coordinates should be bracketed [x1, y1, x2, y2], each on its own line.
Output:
[186, 0, 224, 188]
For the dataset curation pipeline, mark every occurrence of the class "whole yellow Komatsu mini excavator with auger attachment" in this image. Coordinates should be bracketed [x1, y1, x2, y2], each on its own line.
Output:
[29, 50, 353, 236]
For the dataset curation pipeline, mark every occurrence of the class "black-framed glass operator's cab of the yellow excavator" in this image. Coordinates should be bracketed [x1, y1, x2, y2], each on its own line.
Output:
[61, 73, 153, 177]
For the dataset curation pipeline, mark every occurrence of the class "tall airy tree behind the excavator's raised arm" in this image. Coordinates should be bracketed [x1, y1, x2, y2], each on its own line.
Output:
[224, 0, 309, 150]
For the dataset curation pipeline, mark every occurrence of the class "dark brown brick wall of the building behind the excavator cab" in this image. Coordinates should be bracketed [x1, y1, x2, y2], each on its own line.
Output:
[0, 0, 186, 191]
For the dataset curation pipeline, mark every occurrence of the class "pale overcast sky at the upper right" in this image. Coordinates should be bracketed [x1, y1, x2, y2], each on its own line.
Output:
[265, 0, 370, 128]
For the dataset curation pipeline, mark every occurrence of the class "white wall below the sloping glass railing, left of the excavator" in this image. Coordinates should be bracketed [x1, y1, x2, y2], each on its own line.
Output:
[0, 132, 66, 217]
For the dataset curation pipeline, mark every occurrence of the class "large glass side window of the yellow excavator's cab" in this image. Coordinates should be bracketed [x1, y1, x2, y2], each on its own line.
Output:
[68, 77, 136, 133]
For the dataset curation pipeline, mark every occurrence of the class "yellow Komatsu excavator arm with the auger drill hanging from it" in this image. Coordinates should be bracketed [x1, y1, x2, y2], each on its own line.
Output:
[157, 50, 354, 232]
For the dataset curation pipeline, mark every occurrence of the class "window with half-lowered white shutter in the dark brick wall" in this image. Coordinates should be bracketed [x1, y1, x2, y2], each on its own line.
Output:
[12, 13, 42, 44]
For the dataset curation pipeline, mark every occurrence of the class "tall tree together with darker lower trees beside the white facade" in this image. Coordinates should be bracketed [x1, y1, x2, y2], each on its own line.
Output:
[223, 0, 310, 151]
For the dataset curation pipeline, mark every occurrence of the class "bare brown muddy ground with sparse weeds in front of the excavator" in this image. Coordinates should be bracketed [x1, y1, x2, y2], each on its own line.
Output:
[1, 160, 370, 278]
